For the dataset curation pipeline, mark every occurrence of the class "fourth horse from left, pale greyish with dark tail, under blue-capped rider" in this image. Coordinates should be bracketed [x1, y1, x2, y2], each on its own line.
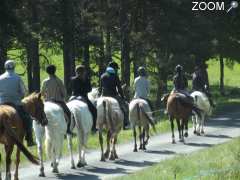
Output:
[96, 97, 124, 161]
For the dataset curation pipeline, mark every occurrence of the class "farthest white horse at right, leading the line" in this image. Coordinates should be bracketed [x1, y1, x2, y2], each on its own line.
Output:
[191, 91, 212, 135]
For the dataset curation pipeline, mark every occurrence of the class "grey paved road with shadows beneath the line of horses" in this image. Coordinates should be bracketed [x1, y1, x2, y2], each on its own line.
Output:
[3, 109, 240, 180]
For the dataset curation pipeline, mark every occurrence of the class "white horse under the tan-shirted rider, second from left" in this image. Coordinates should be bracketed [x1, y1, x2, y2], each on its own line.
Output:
[33, 102, 67, 177]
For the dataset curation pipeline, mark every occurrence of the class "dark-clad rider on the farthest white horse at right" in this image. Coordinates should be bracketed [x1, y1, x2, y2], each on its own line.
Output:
[192, 65, 215, 107]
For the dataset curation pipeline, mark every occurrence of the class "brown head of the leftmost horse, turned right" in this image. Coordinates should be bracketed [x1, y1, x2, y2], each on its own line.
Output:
[22, 93, 48, 126]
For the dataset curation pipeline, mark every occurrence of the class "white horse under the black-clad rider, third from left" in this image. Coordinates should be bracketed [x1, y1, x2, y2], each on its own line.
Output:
[67, 97, 93, 169]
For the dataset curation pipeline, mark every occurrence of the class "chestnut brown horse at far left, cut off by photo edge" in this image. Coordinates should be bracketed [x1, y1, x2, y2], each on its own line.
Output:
[0, 93, 47, 180]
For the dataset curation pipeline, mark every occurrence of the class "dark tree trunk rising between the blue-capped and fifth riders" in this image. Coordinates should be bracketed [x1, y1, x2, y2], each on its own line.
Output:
[120, 0, 130, 90]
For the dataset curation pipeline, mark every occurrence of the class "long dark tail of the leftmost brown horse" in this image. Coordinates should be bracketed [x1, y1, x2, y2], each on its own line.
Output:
[3, 121, 39, 165]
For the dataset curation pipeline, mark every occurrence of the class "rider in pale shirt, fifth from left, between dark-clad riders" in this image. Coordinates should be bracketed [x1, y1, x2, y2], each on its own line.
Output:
[133, 66, 153, 110]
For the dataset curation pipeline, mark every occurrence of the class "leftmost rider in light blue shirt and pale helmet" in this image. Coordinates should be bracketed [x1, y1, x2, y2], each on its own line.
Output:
[0, 60, 35, 146]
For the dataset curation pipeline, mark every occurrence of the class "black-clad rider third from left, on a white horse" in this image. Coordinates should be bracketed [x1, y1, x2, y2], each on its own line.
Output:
[71, 65, 97, 132]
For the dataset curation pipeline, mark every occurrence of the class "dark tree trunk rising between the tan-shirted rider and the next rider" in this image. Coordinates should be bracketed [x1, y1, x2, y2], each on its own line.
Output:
[62, 0, 75, 95]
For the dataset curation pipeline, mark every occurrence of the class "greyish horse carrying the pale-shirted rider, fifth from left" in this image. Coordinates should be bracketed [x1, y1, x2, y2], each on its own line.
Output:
[129, 98, 155, 152]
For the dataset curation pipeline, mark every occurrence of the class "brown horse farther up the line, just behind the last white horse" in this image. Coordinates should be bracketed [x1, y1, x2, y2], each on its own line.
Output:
[165, 92, 199, 143]
